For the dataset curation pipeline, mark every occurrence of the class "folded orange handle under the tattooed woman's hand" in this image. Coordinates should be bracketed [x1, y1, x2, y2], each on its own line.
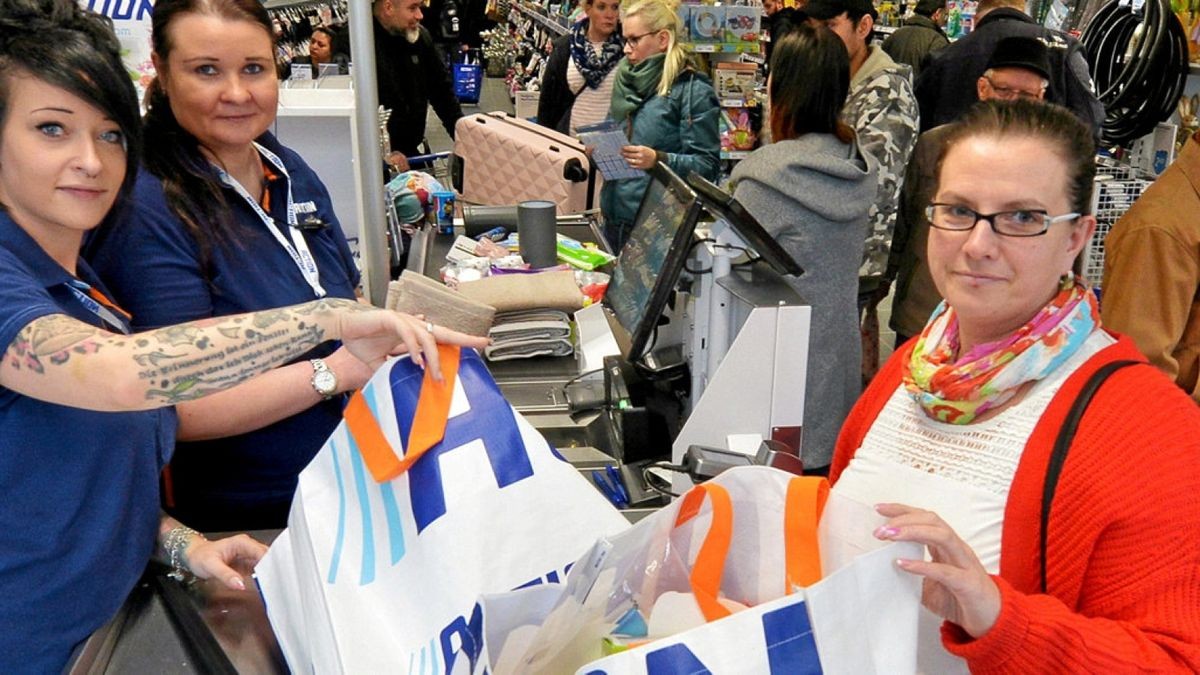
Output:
[343, 345, 461, 483]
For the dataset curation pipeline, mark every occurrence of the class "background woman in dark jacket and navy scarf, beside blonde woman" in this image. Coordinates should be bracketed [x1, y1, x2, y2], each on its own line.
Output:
[538, 0, 625, 133]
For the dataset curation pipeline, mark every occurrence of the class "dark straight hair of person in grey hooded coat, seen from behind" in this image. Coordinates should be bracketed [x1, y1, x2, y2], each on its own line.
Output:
[769, 23, 854, 143]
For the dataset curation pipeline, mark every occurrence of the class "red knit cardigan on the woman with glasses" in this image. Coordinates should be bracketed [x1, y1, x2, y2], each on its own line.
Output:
[829, 336, 1200, 675]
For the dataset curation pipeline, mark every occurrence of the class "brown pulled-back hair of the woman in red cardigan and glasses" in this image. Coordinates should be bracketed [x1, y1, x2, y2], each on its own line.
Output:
[937, 98, 1096, 215]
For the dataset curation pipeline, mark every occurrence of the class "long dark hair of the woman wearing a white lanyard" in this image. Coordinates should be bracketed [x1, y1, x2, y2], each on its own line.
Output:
[145, 0, 275, 270]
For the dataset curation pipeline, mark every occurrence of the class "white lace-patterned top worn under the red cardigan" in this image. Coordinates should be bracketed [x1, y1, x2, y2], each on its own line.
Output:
[822, 330, 1115, 674]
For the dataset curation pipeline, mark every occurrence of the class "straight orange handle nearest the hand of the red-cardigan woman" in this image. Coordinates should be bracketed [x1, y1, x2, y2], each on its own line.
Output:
[784, 476, 829, 595]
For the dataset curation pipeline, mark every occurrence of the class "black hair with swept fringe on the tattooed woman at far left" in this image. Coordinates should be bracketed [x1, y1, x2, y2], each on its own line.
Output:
[0, 0, 142, 210]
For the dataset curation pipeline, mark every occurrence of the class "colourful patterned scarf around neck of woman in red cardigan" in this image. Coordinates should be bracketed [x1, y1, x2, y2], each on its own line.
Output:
[904, 275, 1100, 424]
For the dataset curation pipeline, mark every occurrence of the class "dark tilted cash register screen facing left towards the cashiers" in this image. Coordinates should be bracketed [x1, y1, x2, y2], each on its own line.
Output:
[605, 163, 701, 362]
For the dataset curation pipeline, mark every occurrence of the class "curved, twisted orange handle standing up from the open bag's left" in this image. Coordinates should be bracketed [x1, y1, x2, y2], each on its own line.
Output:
[674, 483, 733, 621]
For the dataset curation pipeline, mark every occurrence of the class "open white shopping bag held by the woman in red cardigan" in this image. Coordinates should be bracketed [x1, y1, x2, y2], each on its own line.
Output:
[476, 467, 920, 675]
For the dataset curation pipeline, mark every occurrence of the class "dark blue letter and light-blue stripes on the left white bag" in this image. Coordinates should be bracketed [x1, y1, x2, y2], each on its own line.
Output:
[326, 350, 533, 586]
